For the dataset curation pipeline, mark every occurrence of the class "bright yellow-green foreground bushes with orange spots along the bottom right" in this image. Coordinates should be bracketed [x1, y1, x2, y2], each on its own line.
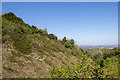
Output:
[50, 55, 119, 78]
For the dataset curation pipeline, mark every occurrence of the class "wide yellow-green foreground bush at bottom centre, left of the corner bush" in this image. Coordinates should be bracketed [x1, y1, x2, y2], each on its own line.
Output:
[51, 56, 101, 78]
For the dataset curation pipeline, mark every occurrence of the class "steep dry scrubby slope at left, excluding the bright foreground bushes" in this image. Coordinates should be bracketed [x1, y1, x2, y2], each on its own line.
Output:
[2, 12, 80, 78]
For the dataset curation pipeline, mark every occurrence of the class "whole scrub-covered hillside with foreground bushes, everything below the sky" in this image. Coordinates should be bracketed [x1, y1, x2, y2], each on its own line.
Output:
[2, 12, 119, 78]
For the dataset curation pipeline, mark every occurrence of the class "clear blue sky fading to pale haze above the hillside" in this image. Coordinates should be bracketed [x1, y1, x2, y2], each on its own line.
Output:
[2, 2, 118, 45]
